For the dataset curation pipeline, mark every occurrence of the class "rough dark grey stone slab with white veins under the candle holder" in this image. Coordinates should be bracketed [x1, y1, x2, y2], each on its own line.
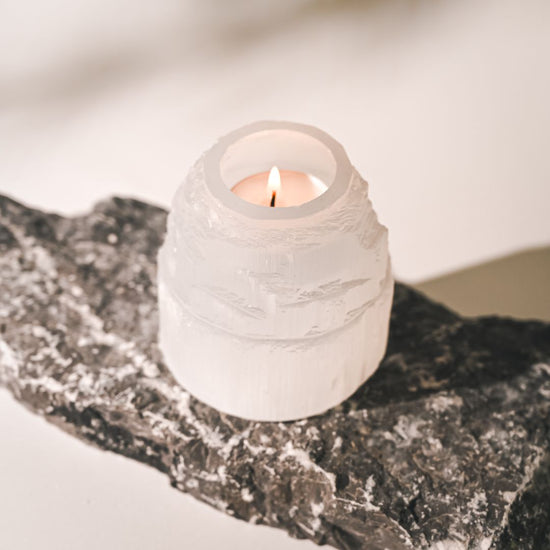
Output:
[0, 197, 550, 550]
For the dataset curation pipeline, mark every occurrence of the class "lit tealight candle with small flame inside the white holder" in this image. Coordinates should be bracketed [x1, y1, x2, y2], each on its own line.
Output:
[231, 166, 327, 207]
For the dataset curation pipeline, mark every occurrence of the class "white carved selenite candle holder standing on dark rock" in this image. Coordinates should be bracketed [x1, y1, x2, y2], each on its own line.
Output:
[158, 122, 393, 421]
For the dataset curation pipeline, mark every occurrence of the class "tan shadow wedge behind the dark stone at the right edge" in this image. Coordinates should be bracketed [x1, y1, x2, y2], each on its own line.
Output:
[416, 246, 550, 321]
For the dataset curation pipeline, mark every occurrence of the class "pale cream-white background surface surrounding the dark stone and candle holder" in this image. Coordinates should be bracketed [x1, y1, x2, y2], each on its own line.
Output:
[0, 0, 550, 550]
